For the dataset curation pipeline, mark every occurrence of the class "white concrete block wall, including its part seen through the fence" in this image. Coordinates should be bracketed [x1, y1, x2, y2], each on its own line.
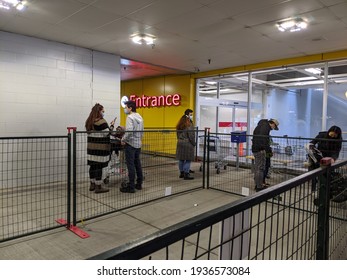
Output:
[0, 31, 120, 189]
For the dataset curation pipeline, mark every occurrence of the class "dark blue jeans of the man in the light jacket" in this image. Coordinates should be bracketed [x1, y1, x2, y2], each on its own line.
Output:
[124, 145, 143, 188]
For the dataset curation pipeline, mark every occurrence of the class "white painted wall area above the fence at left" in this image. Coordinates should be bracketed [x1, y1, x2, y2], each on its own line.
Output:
[0, 31, 120, 137]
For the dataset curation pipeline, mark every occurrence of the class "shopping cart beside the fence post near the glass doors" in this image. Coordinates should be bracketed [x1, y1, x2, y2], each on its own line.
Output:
[199, 135, 228, 174]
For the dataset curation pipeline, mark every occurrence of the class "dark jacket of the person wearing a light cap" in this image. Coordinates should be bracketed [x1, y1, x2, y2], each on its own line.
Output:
[252, 119, 272, 153]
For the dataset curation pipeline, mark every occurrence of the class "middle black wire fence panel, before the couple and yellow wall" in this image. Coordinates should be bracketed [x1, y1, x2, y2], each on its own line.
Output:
[73, 130, 203, 225]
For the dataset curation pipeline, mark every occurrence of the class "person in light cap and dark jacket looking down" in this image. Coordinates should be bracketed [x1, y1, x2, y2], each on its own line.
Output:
[252, 119, 279, 191]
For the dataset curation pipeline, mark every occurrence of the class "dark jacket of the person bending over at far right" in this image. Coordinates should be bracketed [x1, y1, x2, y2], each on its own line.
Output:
[310, 129, 342, 160]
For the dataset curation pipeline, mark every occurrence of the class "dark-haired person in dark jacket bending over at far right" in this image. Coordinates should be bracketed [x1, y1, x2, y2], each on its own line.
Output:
[309, 125, 342, 170]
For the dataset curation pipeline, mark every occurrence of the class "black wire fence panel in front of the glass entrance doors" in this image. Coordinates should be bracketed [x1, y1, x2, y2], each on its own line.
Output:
[203, 132, 347, 195]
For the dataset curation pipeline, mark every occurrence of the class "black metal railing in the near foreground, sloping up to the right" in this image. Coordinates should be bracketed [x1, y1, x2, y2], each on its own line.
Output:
[90, 161, 347, 260]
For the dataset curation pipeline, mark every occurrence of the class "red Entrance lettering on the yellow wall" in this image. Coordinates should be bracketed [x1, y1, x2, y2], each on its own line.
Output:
[129, 93, 181, 108]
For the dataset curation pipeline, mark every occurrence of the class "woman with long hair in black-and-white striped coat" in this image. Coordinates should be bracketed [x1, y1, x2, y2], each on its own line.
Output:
[85, 103, 114, 193]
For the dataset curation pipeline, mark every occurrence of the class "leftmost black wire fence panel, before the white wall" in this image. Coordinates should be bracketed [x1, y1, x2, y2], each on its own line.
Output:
[0, 136, 71, 241]
